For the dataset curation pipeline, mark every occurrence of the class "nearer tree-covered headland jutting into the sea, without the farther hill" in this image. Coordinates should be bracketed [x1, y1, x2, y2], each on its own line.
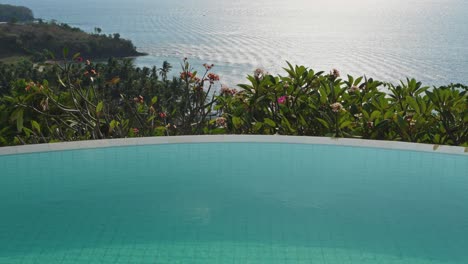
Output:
[0, 22, 142, 61]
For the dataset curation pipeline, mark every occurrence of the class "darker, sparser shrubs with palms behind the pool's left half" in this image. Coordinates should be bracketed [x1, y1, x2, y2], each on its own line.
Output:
[0, 55, 221, 145]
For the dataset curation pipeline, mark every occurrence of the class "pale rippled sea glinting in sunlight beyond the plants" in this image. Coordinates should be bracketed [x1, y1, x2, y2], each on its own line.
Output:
[2, 0, 468, 85]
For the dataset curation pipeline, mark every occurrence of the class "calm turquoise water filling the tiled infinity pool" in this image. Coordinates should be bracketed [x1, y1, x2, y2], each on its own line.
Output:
[0, 143, 468, 264]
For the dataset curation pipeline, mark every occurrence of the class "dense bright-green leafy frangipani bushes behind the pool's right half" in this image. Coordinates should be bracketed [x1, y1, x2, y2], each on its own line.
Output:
[217, 63, 468, 146]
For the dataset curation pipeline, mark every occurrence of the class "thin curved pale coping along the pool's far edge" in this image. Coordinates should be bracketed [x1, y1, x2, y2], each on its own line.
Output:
[0, 135, 468, 157]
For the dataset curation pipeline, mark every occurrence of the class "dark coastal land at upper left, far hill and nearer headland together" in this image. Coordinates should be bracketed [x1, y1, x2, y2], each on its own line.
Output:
[0, 4, 148, 62]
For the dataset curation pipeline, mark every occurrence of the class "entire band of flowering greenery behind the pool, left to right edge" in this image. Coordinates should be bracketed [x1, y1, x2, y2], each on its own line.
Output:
[0, 59, 468, 146]
